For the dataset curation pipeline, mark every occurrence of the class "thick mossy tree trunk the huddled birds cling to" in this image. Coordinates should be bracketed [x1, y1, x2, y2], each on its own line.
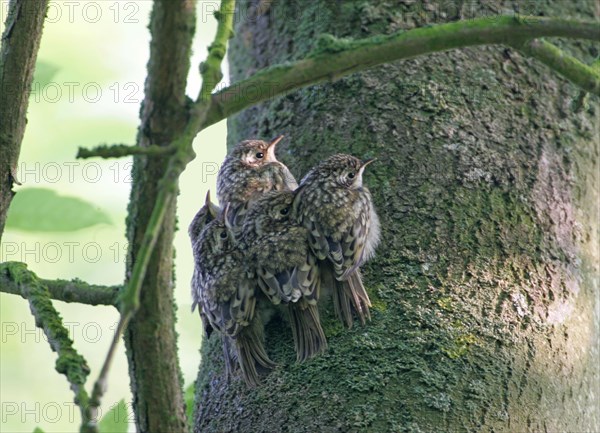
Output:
[195, 0, 600, 432]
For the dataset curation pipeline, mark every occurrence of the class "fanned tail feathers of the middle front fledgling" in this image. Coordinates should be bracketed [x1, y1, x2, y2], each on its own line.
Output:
[289, 300, 327, 361]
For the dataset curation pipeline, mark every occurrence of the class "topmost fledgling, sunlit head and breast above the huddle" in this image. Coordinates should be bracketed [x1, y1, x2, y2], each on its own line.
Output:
[217, 135, 298, 235]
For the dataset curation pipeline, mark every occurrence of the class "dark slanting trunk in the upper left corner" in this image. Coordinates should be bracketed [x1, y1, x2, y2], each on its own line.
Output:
[0, 0, 48, 239]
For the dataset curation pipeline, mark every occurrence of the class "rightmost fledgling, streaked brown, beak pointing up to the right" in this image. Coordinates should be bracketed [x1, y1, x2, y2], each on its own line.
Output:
[294, 154, 380, 326]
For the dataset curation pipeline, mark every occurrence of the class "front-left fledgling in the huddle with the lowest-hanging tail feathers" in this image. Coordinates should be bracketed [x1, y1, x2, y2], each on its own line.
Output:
[193, 206, 274, 386]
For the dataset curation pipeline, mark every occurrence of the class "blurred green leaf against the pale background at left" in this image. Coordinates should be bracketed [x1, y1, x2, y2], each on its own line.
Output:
[6, 188, 111, 232]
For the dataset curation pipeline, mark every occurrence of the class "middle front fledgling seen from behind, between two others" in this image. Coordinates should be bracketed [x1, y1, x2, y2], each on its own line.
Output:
[242, 191, 327, 361]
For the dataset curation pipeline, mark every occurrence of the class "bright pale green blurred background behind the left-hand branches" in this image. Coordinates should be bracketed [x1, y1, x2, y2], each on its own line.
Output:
[0, 1, 226, 432]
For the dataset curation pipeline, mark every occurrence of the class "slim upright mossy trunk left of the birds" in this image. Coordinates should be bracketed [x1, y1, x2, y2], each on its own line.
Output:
[125, 0, 195, 432]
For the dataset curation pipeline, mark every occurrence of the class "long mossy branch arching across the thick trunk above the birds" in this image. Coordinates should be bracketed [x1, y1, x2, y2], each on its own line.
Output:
[200, 16, 600, 129]
